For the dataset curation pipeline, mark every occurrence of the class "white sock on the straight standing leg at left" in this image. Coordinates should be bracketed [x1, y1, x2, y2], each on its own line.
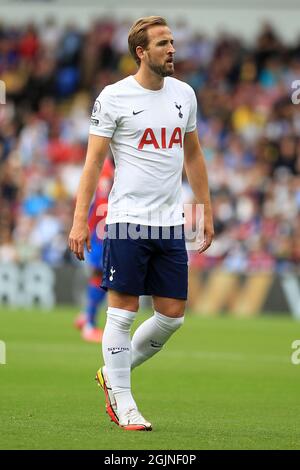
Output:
[102, 307, 137, 415]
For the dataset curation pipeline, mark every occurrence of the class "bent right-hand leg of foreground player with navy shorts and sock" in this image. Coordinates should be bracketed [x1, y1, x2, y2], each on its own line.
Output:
[131, 226, 188, 369]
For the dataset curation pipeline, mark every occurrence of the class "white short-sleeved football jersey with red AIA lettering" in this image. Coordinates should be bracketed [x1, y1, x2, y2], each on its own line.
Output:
[90, 76, 197, 226]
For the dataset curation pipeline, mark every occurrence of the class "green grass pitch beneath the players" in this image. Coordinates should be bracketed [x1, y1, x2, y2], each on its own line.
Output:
[0, 307, 300, 450]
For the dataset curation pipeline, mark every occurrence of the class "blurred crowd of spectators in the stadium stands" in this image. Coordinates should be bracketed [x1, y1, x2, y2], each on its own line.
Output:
[0, 19, 300, 272]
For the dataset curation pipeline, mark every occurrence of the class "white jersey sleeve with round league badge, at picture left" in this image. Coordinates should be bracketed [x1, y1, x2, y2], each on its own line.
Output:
[90, 88, 118, 138]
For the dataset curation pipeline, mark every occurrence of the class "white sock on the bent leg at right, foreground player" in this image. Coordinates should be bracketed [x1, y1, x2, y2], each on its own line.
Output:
[131, 312, 184, 369]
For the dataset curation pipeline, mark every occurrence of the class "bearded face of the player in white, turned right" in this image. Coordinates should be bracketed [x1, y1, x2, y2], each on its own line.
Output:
[144, 26, 175, 77]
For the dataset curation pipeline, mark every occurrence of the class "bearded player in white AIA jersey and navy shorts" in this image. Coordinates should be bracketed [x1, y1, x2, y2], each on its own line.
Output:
[69, 16, 213, 431]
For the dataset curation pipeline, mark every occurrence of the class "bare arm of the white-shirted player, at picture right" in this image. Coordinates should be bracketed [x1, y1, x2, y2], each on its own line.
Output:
[184, 129, 214, 253]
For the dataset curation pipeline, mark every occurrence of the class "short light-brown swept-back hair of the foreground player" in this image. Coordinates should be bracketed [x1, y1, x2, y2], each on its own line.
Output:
[128, 16, 168, 65]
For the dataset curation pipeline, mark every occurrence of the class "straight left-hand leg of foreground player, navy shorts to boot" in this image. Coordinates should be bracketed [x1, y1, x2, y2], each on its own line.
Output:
[98, 224, 151, 430]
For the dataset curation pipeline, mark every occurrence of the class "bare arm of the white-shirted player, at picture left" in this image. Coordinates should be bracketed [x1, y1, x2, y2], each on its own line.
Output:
[69, 134, 111, 260]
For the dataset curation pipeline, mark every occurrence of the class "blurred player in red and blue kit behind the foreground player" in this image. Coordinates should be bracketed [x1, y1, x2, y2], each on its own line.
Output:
[75, 158, 114, 343]
